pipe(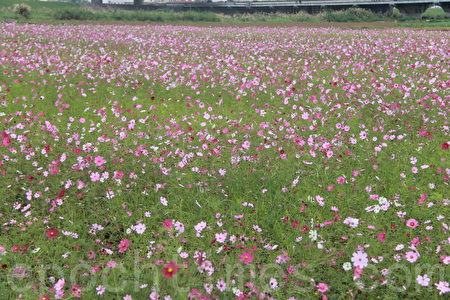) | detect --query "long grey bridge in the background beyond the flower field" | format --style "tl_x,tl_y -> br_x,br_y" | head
91,0 -> 450,16
